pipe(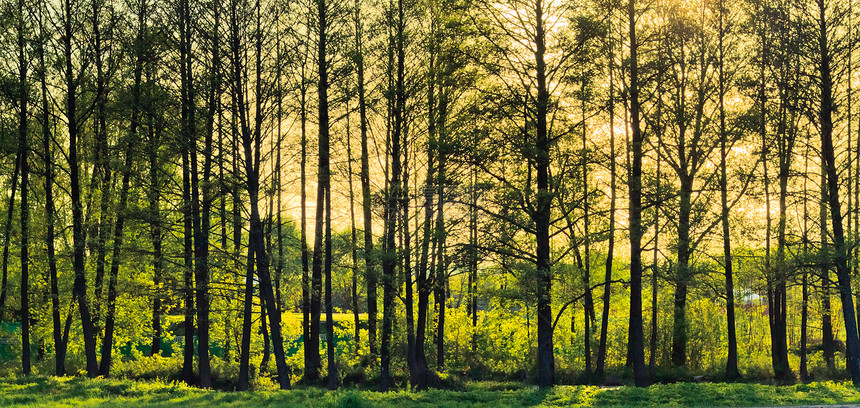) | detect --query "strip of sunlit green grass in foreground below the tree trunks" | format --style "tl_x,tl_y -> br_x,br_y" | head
0,376 -> 860,408
